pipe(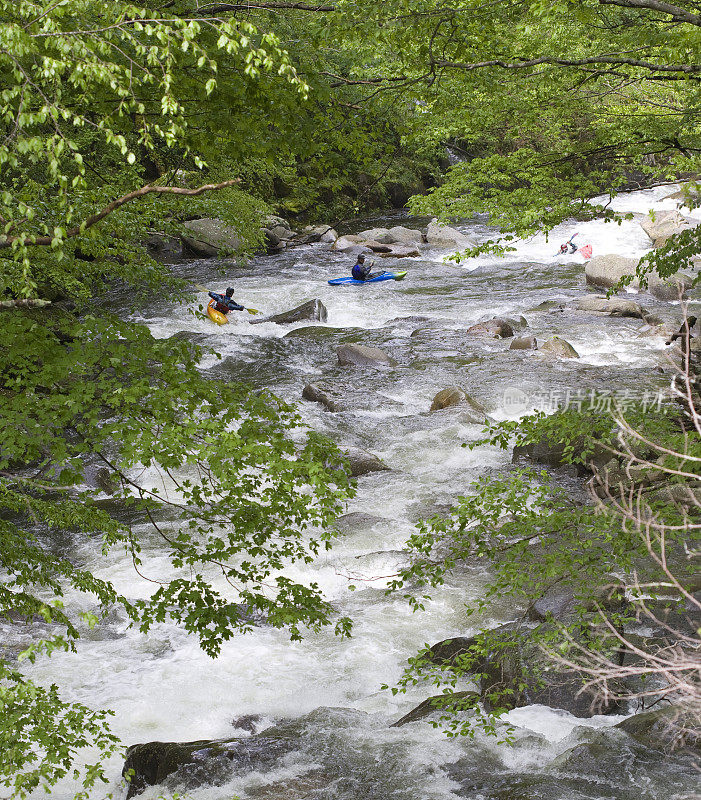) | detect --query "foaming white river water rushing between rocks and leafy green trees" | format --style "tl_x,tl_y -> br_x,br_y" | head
15,188 -> 693,800
